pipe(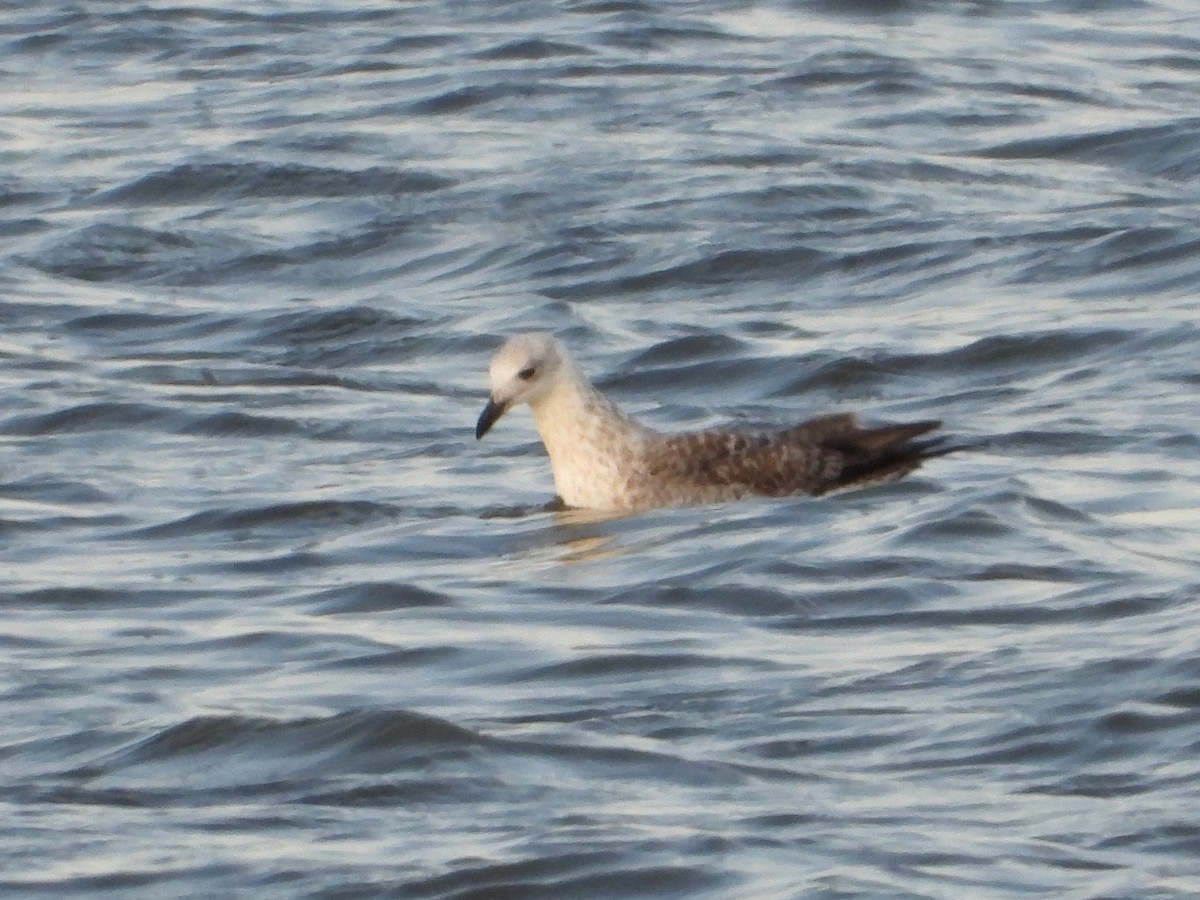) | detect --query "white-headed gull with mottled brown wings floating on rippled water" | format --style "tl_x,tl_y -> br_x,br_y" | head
475,334 -> 955,511
